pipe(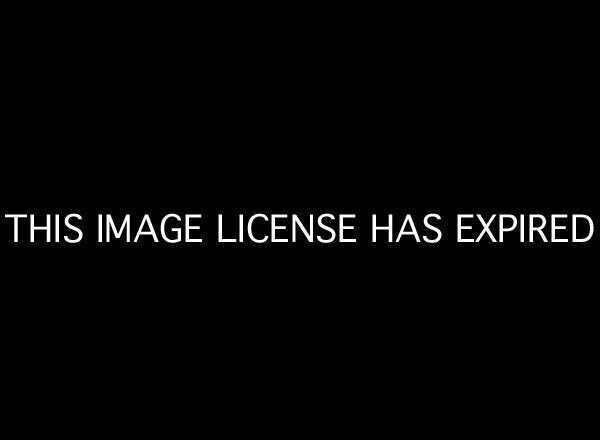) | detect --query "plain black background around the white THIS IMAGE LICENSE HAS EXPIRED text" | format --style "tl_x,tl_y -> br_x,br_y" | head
1,5 -> 598,433
